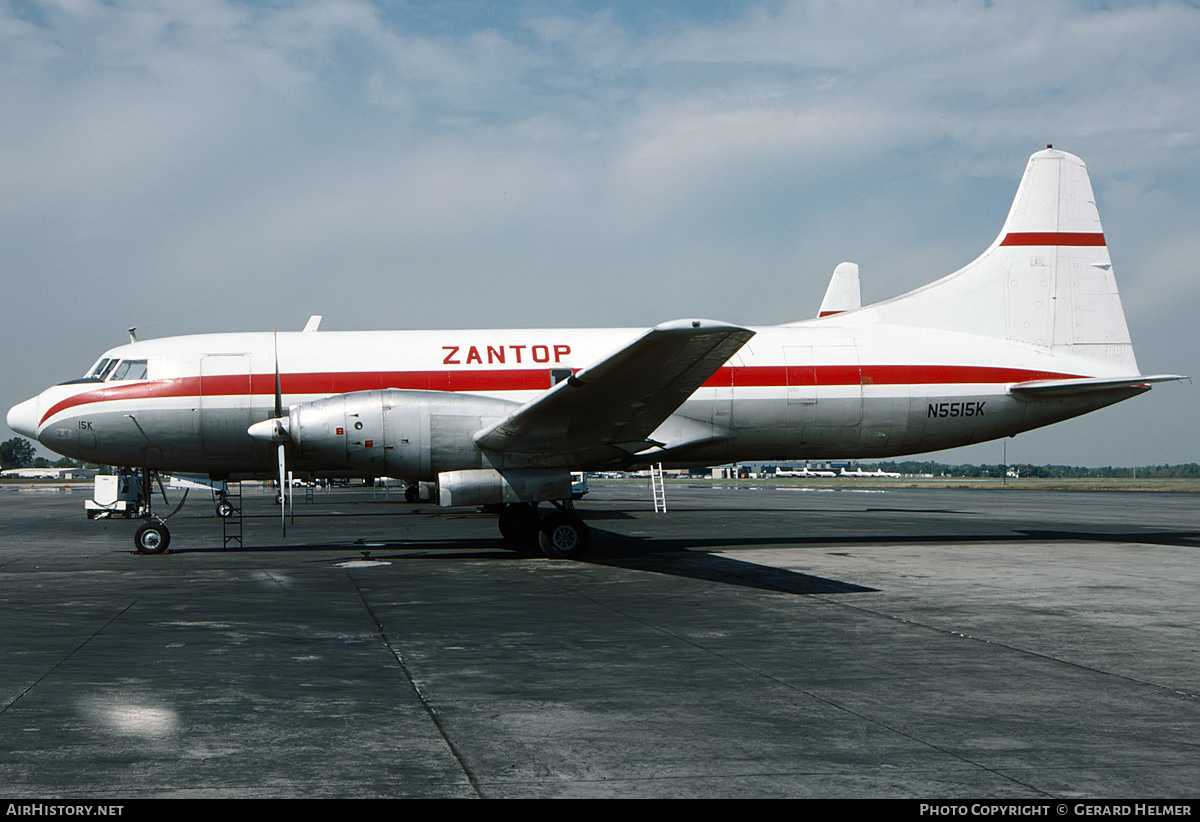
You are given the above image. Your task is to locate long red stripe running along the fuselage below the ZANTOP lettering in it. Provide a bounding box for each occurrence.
[38,365,1084,425]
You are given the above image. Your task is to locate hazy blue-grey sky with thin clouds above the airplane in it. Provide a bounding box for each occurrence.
[0,0,1200,464]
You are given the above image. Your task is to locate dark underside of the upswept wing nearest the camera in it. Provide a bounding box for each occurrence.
[475,319,754,466]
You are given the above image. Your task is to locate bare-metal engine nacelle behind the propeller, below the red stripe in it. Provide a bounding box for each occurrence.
[288,389,518,480]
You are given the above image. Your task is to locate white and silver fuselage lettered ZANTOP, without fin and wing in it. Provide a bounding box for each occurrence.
[8,317,1144,480]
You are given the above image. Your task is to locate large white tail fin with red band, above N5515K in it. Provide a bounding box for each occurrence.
[845,148,1139,374]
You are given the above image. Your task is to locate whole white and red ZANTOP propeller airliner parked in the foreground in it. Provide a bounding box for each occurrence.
[7,149,1178,556]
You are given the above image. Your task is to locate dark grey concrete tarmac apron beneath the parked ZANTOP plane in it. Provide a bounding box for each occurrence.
[0,482,1200,800]
